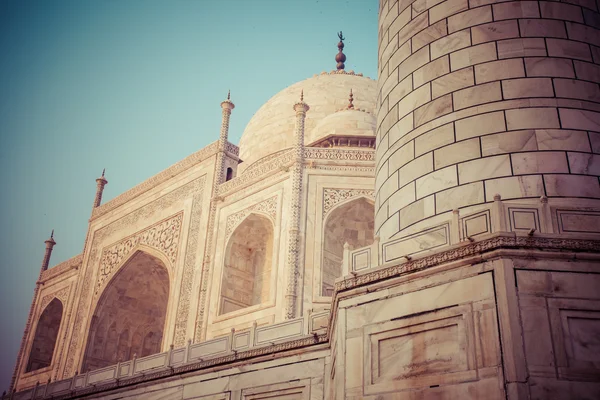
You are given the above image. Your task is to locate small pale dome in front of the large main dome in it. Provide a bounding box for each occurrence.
[305,109,377,145]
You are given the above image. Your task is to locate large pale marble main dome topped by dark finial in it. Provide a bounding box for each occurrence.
[238,71,377,173]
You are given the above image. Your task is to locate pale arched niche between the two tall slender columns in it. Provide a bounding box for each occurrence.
[219,214,273,314]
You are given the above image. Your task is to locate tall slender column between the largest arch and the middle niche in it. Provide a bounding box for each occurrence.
[195,92,235,345]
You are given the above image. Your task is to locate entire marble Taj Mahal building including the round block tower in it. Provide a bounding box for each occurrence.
[2,0,600,400]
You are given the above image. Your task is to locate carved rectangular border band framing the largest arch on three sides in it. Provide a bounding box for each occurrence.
[59,176,206,377]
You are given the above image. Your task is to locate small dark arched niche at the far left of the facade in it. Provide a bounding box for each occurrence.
[25,298,63,372]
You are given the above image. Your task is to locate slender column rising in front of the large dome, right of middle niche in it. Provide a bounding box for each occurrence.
[285,91,310,319]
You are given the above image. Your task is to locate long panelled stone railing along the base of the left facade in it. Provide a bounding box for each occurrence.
[1,310,330,400]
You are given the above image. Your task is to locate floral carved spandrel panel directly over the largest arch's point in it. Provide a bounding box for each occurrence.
[94,212,183,296]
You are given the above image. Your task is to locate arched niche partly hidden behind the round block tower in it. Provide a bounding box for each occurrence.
[321,197,375,296]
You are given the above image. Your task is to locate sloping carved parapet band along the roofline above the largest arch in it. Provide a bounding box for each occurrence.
[91,140,219,220]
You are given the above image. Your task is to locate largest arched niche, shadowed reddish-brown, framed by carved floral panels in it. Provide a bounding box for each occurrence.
[82,250,169,371]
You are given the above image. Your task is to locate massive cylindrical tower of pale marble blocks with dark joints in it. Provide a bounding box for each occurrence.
[375,0,600,240]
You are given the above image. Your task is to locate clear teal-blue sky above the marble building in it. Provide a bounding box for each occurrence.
[0,0,378,392]
